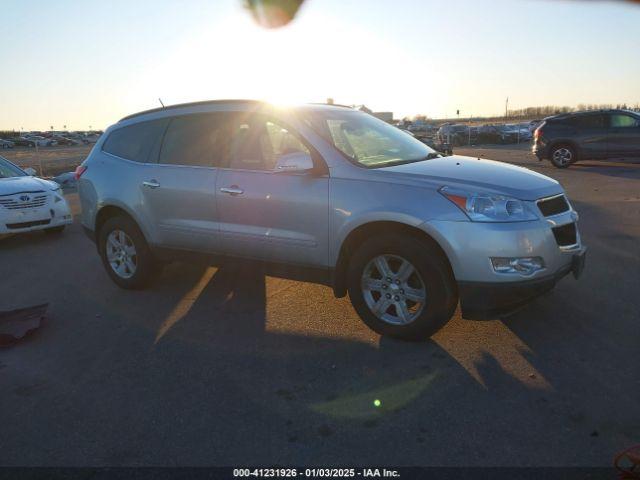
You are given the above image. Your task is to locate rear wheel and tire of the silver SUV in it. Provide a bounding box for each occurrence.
[98,216,162,290]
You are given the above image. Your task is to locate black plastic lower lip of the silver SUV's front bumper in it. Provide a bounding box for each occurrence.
[458,248,586,320]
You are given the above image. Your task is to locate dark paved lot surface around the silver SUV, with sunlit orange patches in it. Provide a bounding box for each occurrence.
[0,147,640,466]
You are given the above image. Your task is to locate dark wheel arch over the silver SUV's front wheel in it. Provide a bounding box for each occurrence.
[332,220,453,298]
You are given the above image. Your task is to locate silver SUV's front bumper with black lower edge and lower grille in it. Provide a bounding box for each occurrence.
[422,199,586,319]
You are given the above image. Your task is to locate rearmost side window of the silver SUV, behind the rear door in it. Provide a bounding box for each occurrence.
[102,119,167,163]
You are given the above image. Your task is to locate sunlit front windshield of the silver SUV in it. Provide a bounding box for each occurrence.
[303,109,439,168]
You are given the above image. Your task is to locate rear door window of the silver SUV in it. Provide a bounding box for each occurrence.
[160,113,230,167]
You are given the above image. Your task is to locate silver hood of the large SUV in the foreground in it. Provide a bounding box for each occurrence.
[379,155,563,200]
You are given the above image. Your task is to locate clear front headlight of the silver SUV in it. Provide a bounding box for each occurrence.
[439,187,538,222]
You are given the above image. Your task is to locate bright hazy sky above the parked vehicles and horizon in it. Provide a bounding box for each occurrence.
[0,0,640,131]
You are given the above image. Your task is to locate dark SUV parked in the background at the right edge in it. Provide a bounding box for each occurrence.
[533,110,640,168]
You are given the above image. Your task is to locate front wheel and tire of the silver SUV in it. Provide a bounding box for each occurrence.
[347,233,458,341]
